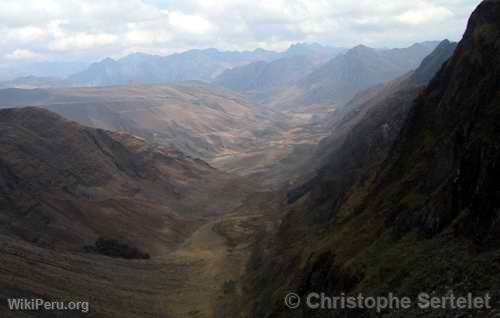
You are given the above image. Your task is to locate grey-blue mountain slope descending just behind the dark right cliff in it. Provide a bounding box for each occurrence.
[289,40,457,201]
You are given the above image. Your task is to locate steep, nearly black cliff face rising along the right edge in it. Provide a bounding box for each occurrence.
[373,1,500,240]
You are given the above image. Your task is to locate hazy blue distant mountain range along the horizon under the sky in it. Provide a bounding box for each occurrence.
[0,42,437,94]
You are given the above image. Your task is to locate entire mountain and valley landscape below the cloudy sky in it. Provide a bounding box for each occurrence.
[0,0,500,318]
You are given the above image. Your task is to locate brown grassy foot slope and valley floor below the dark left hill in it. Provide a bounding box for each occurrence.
[0,206,272,318]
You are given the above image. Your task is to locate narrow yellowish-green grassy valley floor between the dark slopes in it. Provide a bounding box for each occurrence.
[160,192,277,318]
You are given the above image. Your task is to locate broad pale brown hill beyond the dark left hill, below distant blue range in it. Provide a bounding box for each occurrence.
[0,82,277,159]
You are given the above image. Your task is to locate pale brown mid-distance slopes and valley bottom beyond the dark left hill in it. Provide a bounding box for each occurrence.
[0,82,331,187]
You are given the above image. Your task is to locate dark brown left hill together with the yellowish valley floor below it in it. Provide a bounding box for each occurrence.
[0,107,272,317]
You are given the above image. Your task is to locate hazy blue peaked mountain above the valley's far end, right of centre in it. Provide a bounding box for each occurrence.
[260,44,433,109]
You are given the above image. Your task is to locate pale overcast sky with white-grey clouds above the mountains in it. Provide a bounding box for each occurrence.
[0,0,480,64]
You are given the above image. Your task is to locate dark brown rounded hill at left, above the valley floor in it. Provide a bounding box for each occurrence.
[0,107,254,249]
